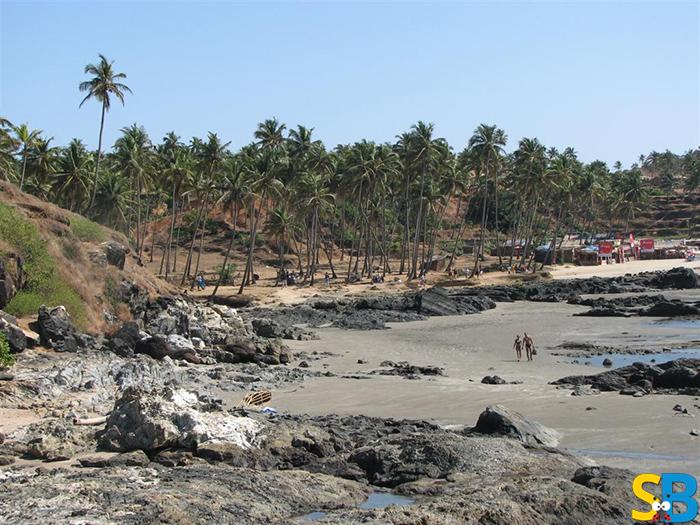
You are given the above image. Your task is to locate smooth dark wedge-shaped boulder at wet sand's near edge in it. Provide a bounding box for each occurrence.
[472,405,559,447]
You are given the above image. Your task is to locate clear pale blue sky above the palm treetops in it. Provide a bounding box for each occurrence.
[0,0,700,165]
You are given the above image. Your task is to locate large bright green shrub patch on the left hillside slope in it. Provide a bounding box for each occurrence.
[0,204,85,325]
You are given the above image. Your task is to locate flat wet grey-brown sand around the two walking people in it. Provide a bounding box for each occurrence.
[273,290,700,475]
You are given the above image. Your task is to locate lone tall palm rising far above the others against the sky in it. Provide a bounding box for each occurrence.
[78,54,132,212]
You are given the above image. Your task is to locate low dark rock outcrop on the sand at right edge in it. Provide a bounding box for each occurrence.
[552,359,700,395]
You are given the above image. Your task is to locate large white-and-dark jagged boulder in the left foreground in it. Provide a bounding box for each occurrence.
[99,388,262,452]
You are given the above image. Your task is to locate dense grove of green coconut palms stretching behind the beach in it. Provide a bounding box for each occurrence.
[0,56,700,291]
